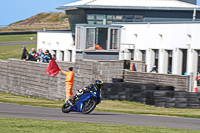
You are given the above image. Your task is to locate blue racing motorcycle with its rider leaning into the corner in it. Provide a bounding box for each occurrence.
[62,80,103,114]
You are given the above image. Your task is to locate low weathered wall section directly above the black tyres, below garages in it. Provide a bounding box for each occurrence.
[124,71,190,91]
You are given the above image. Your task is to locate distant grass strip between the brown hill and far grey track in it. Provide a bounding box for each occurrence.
[0,34,37,43]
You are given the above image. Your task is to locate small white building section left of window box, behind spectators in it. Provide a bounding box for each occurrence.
[37,31,76,62]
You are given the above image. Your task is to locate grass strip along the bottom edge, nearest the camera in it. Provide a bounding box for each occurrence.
[0,117,200,133]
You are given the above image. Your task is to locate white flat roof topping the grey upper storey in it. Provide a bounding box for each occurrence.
[57,0,200,10]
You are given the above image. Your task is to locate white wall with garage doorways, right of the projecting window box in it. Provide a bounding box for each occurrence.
[117,22,200,75]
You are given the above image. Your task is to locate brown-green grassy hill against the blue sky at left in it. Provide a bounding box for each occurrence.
[0,12,70,32]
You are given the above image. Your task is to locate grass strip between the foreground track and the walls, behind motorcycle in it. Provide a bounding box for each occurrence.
[0,92,200,118]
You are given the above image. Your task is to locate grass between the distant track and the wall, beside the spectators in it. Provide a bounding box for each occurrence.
[0,43,37,60]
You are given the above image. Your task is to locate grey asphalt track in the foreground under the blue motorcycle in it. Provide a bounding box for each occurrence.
[0,102,200,130]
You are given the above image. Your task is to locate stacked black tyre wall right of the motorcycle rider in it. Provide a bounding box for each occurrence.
[101,82,200,108]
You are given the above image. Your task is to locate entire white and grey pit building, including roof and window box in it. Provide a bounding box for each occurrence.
[38,0,200,75]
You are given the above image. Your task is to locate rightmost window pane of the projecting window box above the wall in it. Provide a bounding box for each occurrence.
[110,29,119,49]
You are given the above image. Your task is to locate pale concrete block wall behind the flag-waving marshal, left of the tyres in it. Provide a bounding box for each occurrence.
[0,59,123,100]
